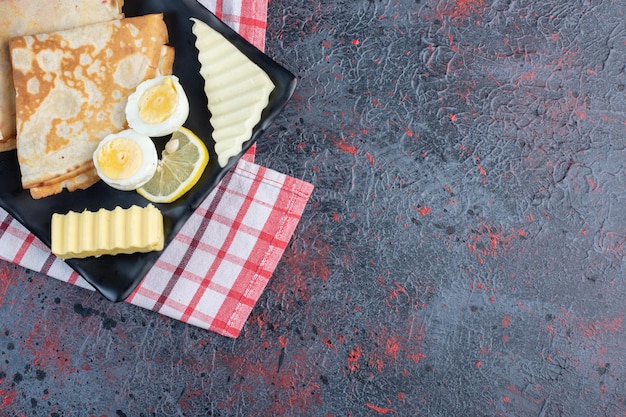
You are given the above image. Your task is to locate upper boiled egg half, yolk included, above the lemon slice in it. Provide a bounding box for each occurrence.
[125,75,189,137]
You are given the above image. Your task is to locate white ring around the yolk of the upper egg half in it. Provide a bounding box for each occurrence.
[125,75,189,137]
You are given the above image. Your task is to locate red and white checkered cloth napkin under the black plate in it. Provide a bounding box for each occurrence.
[0,0,313,337]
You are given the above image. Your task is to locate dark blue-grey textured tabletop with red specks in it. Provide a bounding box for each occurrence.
[0,0,626,417]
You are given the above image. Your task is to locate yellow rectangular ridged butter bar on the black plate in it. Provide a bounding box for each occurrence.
[51,204,164,259]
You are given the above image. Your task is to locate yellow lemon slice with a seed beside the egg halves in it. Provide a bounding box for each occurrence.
[137,127,209,203]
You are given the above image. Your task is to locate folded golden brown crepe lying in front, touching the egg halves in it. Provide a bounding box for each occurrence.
[10,14,173,198]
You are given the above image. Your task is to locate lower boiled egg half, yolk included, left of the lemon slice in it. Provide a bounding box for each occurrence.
[93,129,159,191]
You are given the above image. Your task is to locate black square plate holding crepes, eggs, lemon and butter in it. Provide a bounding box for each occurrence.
[0,0,296,301]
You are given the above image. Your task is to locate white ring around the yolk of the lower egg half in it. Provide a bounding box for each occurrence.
[93,129,159,191]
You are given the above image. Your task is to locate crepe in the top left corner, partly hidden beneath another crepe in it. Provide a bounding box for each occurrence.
[0,0,123,152]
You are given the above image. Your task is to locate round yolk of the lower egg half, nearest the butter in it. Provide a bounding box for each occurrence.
[97,138,143,180]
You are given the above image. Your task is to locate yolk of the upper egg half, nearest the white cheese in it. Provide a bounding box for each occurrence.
[138,78,178,124]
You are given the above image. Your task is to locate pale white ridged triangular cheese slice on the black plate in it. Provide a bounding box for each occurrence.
[191,18,275,167]
